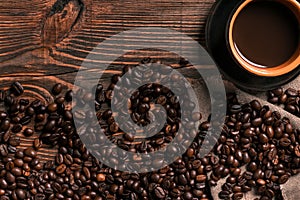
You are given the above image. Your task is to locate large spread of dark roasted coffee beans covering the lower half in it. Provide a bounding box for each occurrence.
[0,61,300,200]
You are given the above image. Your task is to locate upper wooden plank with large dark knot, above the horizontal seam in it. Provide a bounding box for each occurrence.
[0,0,213,74]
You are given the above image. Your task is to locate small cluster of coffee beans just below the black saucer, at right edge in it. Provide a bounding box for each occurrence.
[267,88,300,117]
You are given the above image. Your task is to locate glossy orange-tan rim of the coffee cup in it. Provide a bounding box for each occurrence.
[228,0,300,77]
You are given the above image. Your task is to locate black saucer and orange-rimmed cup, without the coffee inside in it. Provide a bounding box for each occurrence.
[206,0,300,91]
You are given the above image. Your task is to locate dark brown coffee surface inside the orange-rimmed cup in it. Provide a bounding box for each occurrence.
[232,1,299,68]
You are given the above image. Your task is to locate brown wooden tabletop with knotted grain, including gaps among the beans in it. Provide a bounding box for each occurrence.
[0,0,214,164]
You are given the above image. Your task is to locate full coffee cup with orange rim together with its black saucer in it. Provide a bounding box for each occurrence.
[206,0,300,91]
